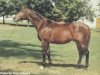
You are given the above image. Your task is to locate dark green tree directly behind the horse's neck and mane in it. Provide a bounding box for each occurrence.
[22,0,63,20]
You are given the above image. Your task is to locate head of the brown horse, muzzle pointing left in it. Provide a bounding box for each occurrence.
[13,9,28,22]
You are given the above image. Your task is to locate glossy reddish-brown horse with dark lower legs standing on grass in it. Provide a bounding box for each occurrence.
[13,8,90,68]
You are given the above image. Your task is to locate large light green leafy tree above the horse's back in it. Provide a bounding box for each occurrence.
[52,0,94,21]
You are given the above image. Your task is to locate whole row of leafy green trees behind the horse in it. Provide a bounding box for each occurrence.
[0,0,94,23]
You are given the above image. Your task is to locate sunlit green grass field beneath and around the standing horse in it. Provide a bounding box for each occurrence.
[0,24,100,75]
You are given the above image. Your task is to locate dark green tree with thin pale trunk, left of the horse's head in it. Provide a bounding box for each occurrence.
[0,0,23,23]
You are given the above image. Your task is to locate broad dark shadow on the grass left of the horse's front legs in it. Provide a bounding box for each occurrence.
[0,40,41,59]
